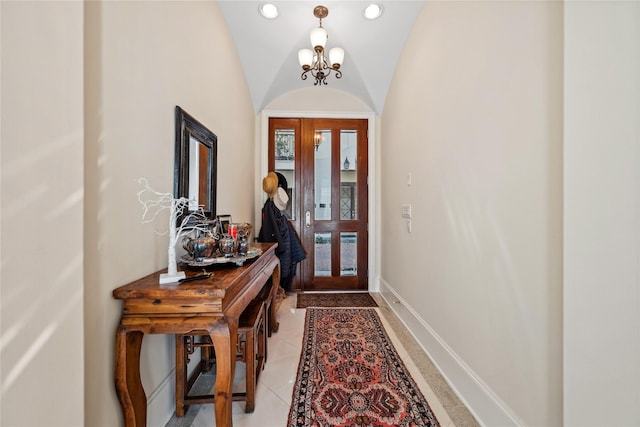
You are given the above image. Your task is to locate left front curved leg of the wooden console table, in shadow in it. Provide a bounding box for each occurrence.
[115,325,147,427]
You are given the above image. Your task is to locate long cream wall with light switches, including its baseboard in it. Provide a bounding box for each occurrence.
[380,1,562,426]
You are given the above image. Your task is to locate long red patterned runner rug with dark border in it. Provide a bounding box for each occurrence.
[288,308,439,427]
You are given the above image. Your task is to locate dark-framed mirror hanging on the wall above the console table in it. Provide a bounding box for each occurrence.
[173,106,218,219]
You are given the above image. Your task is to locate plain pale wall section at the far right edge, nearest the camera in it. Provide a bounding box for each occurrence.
[563,1,640,426]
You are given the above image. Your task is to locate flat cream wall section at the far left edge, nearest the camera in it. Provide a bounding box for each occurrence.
[0,1,85,427]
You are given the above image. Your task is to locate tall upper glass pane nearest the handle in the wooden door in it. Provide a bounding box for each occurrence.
[313,129,331,221]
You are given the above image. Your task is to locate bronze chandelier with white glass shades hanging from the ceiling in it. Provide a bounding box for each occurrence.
[298,6,344,86]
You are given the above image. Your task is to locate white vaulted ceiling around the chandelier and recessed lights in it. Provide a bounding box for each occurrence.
[218,0,424,114]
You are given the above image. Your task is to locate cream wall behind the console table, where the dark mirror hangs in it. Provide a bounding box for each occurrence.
[85,1,255,427]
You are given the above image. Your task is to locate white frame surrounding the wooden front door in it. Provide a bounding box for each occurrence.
[254,110,380,292]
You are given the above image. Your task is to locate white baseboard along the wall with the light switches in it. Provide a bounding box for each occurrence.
[379,278,524,426]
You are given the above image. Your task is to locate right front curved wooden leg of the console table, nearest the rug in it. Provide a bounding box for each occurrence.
[209,318,238,427]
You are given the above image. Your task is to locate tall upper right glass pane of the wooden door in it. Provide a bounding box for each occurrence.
[340,130,358,220]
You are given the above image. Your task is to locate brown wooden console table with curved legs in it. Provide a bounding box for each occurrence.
[113,243,280,427]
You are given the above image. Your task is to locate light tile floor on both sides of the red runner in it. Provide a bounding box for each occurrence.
[165,294,479,427]
